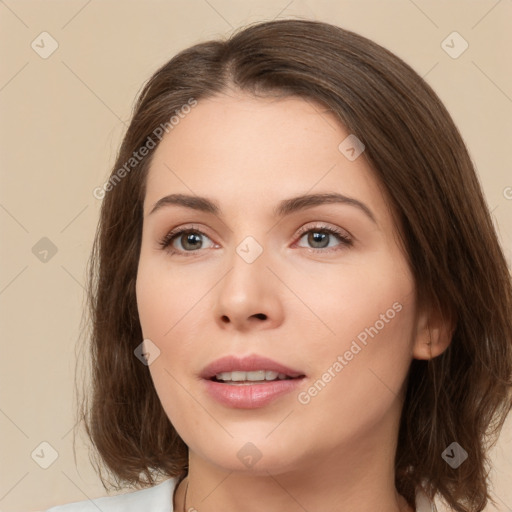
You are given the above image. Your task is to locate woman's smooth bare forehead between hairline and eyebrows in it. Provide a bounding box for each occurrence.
[144,93,390,224]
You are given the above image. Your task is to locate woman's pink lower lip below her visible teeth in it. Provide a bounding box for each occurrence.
[204,378,303,409]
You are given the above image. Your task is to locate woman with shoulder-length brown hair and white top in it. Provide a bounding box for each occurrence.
[46,20,512,512]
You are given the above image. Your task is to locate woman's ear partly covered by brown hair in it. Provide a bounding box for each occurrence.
[413,309,455,359]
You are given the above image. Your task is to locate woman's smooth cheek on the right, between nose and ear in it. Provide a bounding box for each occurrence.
[298,252,416,388]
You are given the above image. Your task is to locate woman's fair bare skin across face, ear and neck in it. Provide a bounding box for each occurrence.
[137,91,449,512]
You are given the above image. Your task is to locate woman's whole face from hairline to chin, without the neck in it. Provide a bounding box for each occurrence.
[137,93,419,474]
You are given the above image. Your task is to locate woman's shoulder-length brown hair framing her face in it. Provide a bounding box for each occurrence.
[79,20,512,512]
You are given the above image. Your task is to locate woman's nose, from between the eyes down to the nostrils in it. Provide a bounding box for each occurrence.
[213,243,284,331]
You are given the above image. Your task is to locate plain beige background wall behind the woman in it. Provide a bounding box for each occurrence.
[0,0,512,511]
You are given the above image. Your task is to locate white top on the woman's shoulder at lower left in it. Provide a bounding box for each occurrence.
[46,478,176,512]
